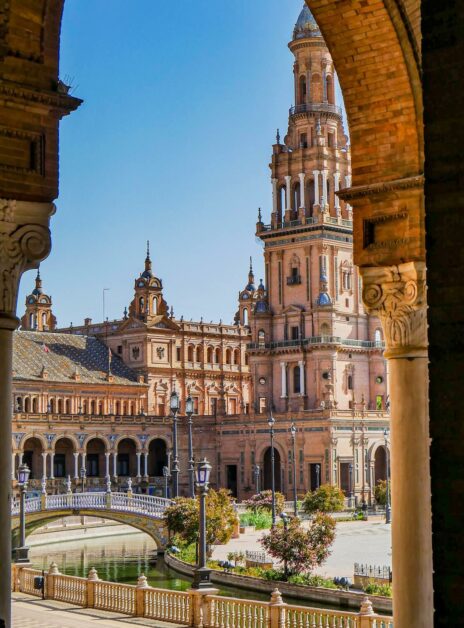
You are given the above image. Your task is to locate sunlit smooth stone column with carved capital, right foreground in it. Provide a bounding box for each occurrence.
[360,262,433,628]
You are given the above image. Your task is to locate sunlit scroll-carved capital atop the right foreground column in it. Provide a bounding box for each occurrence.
[360,262,428,358]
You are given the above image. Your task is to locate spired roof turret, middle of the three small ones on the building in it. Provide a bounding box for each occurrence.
[129,242,168,324]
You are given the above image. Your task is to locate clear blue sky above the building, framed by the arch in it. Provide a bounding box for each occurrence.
[18,0,342,326]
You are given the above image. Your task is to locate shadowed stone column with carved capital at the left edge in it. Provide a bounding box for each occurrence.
[0,199,54,628]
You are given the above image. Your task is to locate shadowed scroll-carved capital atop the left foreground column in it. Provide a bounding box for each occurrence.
[0,199,55,328]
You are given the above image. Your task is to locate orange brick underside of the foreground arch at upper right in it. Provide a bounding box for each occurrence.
[306,0,423,186]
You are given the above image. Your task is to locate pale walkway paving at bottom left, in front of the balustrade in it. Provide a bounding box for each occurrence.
[12,593,180,628]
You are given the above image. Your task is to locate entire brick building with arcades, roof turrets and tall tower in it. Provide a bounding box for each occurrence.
[13,7,389,503]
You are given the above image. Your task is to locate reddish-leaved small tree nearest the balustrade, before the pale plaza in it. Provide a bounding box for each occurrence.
[260,512,335,575]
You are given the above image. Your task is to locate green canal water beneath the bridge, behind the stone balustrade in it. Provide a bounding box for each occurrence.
[29,533,342,608]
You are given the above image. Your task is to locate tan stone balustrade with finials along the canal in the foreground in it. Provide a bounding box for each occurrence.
[12,563,393,628]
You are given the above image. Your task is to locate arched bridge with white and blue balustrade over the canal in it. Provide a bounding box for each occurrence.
[11,492,171,552]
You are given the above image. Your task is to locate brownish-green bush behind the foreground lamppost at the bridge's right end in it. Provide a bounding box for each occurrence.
[165,489,238,546]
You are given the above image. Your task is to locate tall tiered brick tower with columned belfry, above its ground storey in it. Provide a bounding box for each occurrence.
[246,6,387,413]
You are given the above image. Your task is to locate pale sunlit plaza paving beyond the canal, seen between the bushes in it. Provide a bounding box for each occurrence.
[213,516,391,578]
